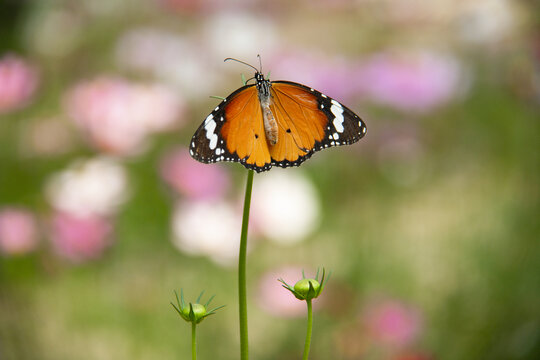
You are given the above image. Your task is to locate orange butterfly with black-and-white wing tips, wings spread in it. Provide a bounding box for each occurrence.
[189,57,366,172]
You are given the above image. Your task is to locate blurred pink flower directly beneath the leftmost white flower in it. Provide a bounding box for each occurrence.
[51,213,112,263]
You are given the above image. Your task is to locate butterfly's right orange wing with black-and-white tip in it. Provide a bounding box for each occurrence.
[269,81,366,167]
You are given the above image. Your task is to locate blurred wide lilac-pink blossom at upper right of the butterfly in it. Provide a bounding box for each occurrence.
[352,52,467,112]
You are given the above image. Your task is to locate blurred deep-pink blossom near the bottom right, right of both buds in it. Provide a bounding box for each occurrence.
[364,300,422,347]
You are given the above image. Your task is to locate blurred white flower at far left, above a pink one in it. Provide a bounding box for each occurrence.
[46,157,128,216]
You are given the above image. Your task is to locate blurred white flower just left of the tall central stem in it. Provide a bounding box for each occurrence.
[172,201,242,265]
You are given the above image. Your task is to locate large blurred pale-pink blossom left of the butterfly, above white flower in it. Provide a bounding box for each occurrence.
[66,77,185,155]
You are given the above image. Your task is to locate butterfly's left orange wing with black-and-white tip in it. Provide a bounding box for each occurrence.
[190,85,271,172]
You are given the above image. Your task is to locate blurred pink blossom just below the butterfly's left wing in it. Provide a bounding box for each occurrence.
[160,148,230,200]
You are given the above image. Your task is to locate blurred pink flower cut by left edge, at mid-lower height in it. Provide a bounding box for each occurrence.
[0,208,38,255]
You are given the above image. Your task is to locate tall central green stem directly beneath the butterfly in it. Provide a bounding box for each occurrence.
[238,170,253,360]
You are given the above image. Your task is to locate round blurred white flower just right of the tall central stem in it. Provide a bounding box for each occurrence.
[251,169,320,244]
